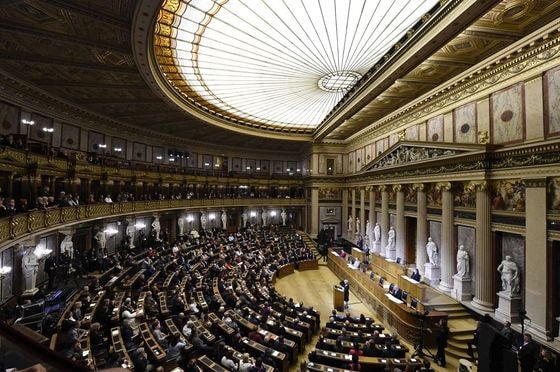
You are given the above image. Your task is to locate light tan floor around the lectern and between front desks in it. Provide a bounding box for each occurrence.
[275,264,458,371]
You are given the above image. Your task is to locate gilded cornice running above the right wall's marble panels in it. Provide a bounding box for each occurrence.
[345,25,560,151]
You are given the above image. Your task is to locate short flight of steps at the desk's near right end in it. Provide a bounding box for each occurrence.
[433,302,476,361]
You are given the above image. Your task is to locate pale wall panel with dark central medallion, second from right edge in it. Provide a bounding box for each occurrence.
[490,84,525,144]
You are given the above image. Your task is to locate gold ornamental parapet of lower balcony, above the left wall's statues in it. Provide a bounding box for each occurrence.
[0,198,305,250]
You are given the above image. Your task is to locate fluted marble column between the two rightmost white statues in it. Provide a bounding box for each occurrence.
[468,181,496,313]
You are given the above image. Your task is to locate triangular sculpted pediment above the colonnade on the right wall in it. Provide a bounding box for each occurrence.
[361,141,488,172]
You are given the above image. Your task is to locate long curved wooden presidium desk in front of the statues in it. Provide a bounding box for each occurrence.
[328,249,447,345]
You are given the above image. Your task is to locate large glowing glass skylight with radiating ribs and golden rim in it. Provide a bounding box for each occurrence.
[154,0,439,133]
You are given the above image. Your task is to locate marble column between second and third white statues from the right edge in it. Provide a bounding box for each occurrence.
[436,182,455,293]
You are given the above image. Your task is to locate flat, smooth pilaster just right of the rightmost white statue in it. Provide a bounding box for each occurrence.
[521,178,556,339]
